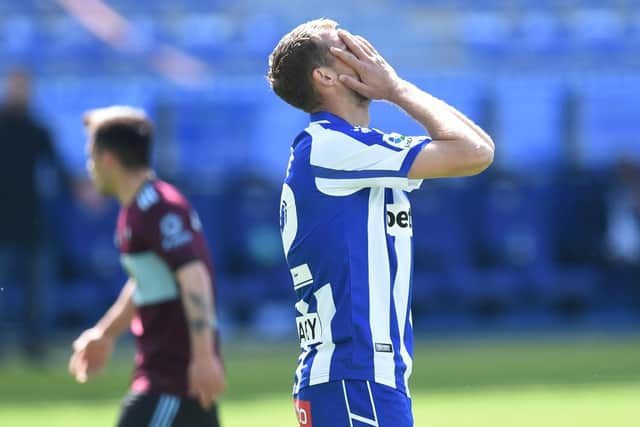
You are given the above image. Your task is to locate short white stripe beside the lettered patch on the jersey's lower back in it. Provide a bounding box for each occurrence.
[309,283,336,385]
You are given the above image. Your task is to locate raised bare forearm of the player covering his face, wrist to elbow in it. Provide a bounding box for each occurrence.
[390,81,492,147]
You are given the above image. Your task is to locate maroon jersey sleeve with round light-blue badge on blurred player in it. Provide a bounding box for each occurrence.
[144,204,201,271]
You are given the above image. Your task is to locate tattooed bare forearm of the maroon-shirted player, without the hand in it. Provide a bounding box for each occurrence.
[177,261,215,357]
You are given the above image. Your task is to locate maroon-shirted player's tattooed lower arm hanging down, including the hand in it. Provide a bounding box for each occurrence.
[176,260,225,408]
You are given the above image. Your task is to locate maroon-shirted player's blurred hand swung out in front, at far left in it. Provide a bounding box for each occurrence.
[69,328,113,383]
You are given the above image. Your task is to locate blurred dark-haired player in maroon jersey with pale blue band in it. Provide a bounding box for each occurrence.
[69,106,224,427]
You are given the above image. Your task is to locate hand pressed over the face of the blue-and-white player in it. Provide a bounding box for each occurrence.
[330,30,401,100]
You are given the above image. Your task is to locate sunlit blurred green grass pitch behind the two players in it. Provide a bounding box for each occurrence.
[0,335,640,427]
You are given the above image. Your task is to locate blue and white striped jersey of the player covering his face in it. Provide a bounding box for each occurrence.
[280,112,430,394]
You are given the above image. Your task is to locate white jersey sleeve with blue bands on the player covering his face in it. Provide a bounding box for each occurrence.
[310,127,431,195]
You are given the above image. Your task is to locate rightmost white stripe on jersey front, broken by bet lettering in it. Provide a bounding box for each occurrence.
[393,190,413,397]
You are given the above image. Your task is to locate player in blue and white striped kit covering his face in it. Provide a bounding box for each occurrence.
[267,19,494,427]
